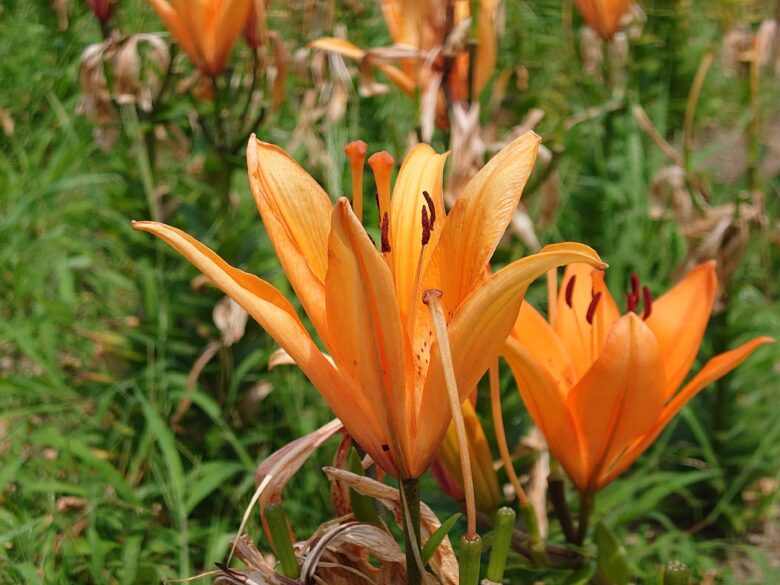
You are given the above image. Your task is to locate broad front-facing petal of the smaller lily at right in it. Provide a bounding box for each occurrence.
[566,313,664,489]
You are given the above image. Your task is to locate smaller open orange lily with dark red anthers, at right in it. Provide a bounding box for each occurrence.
[504,262,772,492]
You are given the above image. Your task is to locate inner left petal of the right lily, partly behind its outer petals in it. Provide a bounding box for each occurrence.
[509,302,576,396]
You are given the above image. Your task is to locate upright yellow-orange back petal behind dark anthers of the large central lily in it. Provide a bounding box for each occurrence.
[390,144,447,326]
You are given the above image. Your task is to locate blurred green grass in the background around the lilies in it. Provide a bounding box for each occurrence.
[0,0,780,584]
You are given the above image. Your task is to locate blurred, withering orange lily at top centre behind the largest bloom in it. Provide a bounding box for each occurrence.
[311,0,497,103]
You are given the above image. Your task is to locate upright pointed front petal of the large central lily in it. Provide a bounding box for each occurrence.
[325,199,412,477]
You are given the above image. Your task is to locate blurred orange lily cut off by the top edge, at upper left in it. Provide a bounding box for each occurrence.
[149,0,250,77]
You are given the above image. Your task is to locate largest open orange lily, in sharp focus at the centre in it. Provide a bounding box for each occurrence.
[134,133,604,479]
